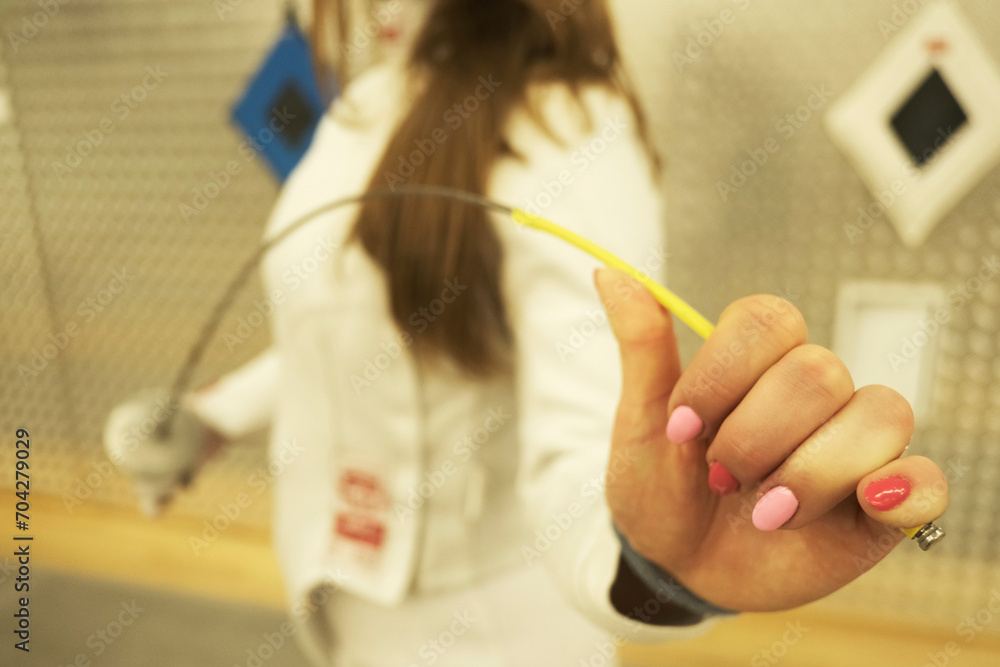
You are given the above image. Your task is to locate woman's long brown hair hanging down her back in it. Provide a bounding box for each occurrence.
[313,0,659,377]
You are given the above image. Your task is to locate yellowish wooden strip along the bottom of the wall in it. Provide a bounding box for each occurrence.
[25,488,1000,667]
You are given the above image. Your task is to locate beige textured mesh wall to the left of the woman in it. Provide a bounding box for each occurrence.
[0,0,304,522]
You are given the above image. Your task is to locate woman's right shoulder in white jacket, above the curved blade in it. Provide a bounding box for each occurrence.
[490,76,662,266]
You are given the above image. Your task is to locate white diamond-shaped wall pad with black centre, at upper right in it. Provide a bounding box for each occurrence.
[825,0,1000,247]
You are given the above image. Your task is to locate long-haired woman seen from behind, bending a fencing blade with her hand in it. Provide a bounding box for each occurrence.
[184,0,943,666]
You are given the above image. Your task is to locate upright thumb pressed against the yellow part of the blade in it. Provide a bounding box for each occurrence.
[594,268,681,416]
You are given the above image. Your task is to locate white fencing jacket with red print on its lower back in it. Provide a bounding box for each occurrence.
[196,66,707,641]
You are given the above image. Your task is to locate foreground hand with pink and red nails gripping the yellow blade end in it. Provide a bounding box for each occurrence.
[595,269,948,611]
